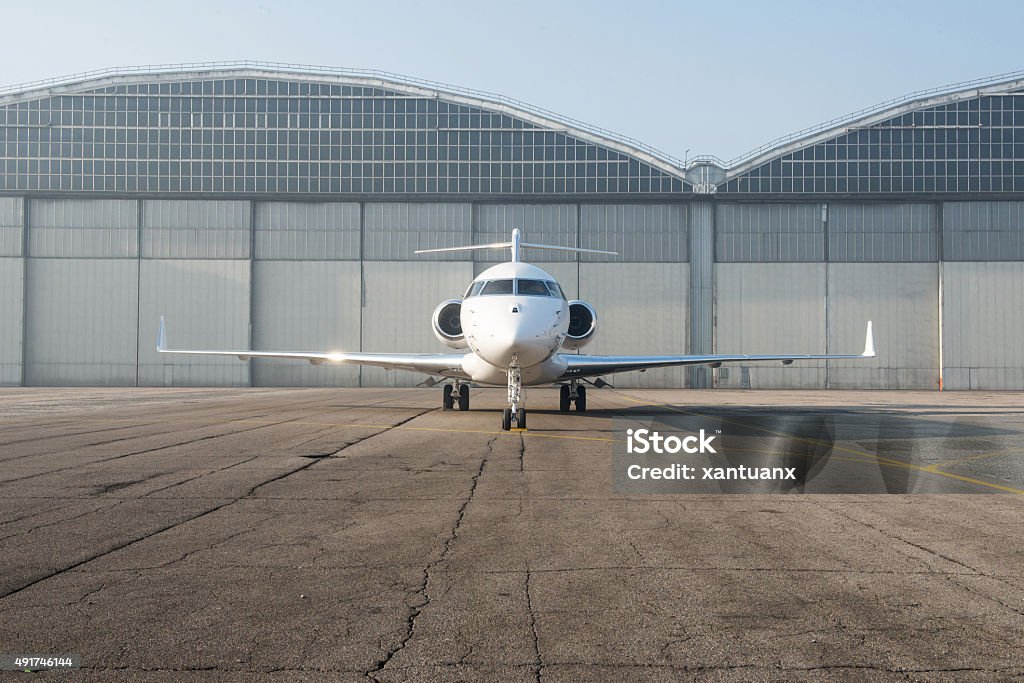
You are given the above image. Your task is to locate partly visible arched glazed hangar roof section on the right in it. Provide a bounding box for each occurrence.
[712,73,1024,195]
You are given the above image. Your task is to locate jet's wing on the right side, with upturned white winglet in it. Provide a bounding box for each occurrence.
[559,321,874,379]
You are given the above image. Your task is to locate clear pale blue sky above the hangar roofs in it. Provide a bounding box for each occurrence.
[0,0,1024,160]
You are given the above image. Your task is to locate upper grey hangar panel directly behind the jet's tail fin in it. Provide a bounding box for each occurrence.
[473,204,579,263]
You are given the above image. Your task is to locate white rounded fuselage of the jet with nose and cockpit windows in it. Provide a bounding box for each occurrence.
[462,261,569,384]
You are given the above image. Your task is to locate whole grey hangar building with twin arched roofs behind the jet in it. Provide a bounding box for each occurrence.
[0,61,1024,389]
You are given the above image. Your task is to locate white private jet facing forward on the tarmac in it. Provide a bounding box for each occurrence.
[157,228,874,431]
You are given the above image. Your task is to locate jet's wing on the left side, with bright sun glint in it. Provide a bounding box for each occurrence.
[157,316,469,379]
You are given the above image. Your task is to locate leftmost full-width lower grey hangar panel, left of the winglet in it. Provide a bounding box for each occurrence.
[25,258,138,386]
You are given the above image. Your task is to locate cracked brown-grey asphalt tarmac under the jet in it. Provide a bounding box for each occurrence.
[0,387,1024,681]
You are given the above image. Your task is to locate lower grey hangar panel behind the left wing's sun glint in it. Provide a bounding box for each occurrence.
[252,261,360,386]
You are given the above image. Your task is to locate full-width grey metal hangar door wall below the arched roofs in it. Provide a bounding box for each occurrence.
[0,198,1024,389]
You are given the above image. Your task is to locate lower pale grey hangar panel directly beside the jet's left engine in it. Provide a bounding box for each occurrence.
[362,261,473,393]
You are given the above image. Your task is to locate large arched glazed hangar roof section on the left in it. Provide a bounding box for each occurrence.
[0,61,691,195]
